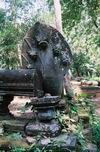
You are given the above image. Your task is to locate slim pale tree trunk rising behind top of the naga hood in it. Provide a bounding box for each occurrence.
[54,0,62,33]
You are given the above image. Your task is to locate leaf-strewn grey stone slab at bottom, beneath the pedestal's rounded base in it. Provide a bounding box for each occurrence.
[26,133,77,152]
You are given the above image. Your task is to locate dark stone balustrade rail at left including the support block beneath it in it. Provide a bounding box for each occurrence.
[0,69,37,114]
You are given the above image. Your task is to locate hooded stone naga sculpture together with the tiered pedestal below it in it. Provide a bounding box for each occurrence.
[22,22,72,140]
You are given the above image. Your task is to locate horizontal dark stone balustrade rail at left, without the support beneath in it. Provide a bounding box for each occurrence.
[0,69,43,96]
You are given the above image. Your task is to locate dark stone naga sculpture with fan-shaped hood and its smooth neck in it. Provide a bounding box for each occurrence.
[22,22,72,95]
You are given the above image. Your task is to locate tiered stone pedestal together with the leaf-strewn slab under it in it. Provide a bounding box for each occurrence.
[25,95,77,151]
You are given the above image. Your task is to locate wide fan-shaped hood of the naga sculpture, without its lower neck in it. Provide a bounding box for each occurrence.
[22,22,72,68]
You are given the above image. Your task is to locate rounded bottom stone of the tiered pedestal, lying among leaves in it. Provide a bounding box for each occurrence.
[25,120,61,137]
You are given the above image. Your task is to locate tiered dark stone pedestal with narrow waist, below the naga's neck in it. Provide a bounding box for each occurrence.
[25,95,61,137]
